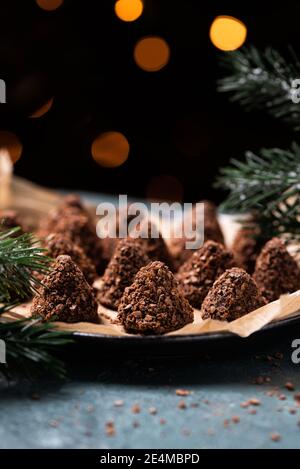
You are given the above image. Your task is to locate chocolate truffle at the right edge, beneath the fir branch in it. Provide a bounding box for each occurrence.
[253,238,300,301]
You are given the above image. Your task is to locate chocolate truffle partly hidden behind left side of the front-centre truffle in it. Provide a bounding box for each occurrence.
[98,238,149,309]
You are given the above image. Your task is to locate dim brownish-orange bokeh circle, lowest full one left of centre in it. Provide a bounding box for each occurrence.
[91,132,130,168]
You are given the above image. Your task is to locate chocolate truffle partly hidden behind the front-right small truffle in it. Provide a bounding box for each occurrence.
[177,241,234,309]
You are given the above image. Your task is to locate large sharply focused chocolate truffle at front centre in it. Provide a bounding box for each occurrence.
[118,261,194,334]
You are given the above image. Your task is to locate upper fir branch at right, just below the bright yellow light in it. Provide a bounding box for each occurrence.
[218,46,300,131]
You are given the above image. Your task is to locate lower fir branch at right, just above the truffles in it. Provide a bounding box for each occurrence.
[216,143,300,240]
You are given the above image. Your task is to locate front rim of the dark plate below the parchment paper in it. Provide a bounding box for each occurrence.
[74,312,300,356]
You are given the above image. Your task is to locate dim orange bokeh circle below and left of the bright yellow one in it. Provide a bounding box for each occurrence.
[134,36,170,72]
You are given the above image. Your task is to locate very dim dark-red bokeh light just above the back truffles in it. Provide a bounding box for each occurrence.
[146,174,183,202]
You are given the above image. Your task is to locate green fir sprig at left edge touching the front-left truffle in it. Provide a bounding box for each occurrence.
[0,228,51,312]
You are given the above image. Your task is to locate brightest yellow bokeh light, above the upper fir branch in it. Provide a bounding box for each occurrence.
[209,16,247,51]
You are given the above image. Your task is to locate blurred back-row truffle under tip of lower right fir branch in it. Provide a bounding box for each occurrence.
[232,225,262,274]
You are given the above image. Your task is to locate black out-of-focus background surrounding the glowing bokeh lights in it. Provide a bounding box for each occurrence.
[0,0,300,201]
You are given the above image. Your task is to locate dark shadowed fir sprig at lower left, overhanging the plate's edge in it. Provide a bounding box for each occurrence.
[0,319,73,378]
